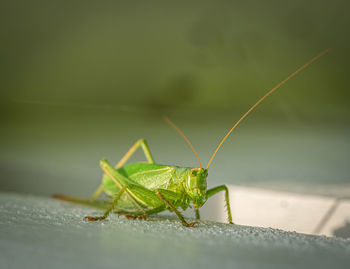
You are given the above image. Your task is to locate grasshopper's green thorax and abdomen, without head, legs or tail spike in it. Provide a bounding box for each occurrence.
[102,163,191,215]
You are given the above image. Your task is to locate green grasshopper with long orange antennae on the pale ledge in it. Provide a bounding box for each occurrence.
[54,50,328,227]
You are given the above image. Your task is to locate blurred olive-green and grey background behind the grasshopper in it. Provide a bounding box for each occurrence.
[0,0,350,197]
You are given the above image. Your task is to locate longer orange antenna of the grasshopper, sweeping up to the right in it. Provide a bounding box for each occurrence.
[206,49,330,169]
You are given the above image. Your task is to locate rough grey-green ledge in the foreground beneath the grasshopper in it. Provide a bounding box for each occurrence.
[0,193,350,268]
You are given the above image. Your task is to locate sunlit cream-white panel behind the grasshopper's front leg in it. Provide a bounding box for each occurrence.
[213,185,350,238]
